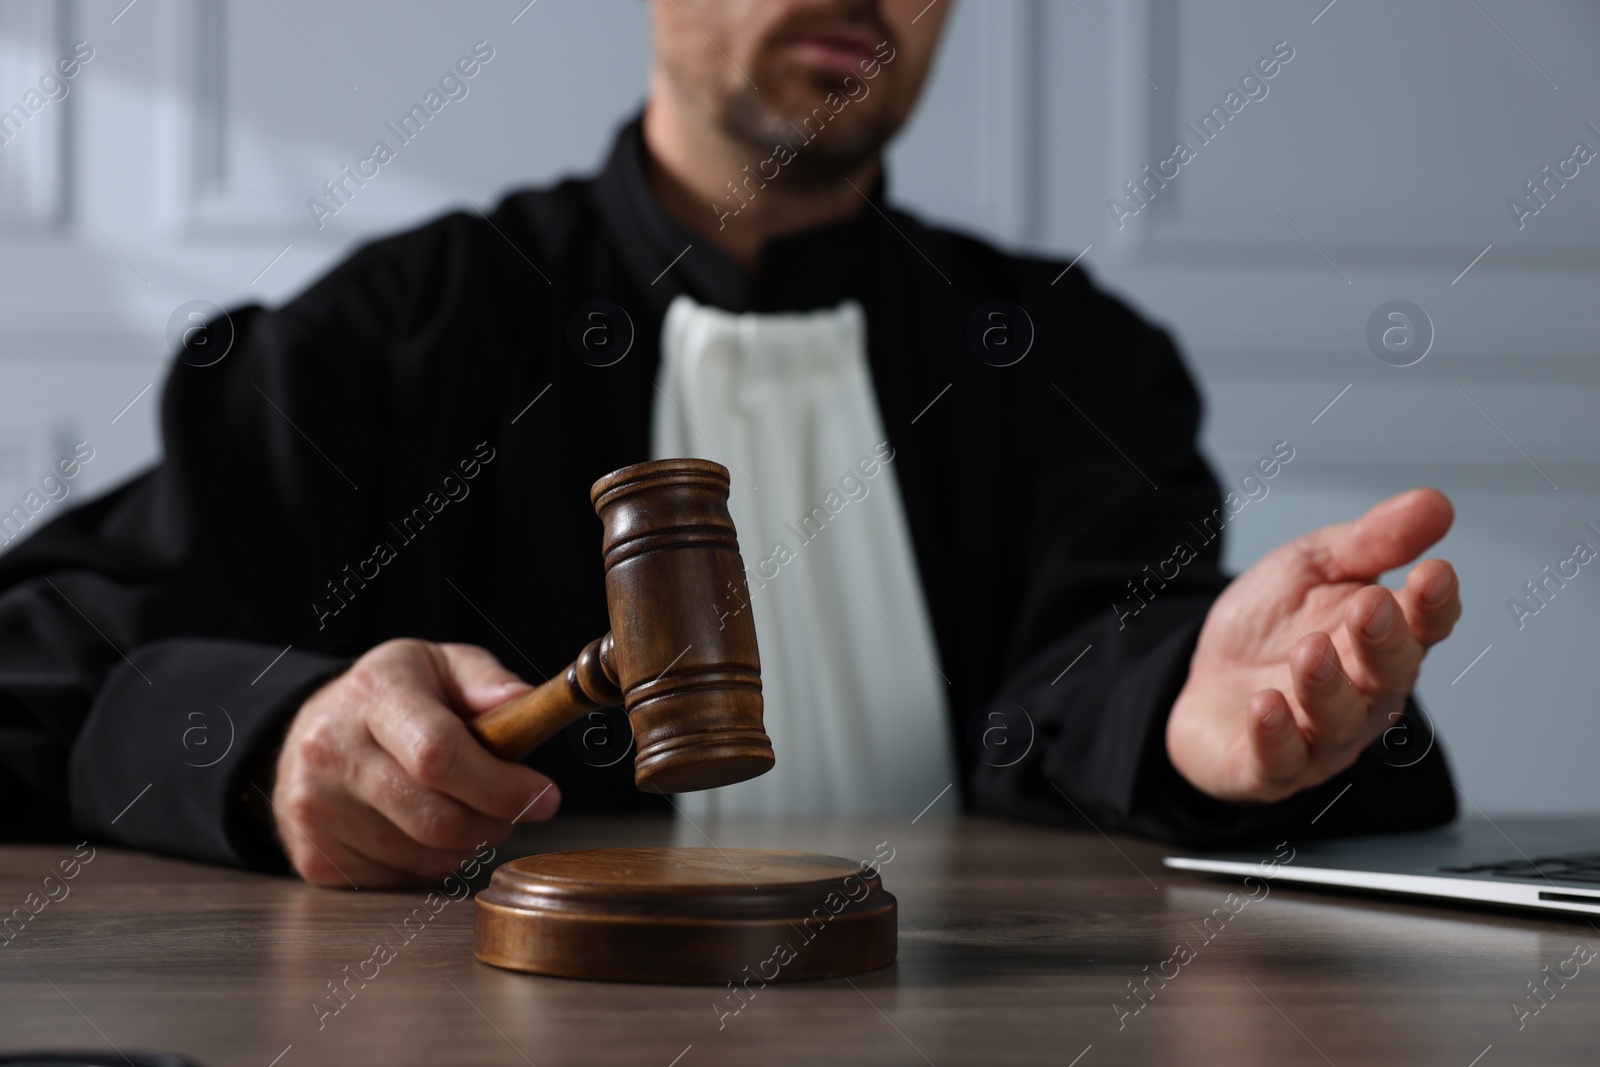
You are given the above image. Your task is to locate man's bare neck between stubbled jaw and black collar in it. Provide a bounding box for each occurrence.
[643,85,882,270]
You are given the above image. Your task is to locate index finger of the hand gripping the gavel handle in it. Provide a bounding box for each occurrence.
[366,688,562,822]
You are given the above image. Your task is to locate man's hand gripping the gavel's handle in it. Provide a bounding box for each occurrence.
[272,640,562,889]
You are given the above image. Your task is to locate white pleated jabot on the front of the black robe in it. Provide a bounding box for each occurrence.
[651,296,955,817]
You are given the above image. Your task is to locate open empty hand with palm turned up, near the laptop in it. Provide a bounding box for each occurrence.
[1166,490,1461,803]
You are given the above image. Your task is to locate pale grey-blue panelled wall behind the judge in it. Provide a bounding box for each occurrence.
[0,0,1600,811]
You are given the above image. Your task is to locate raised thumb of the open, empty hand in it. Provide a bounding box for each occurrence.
[1293,490,1456,582]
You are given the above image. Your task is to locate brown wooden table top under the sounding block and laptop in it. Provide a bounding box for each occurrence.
[0,814,1600,1067]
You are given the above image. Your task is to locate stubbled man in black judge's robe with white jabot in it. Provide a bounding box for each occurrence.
[0,0,1459,886]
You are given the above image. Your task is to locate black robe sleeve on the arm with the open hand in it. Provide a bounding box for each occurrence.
[968,281,1454,846]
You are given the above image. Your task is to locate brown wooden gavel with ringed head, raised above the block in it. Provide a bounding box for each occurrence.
[469,459,773,793]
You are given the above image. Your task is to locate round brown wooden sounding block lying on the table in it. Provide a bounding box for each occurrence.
[474,848,896,985]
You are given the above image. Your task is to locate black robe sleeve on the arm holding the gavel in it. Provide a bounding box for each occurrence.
[0,233,418,867]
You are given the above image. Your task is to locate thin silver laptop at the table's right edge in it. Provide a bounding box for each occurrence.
[1163,816,1600,915]
